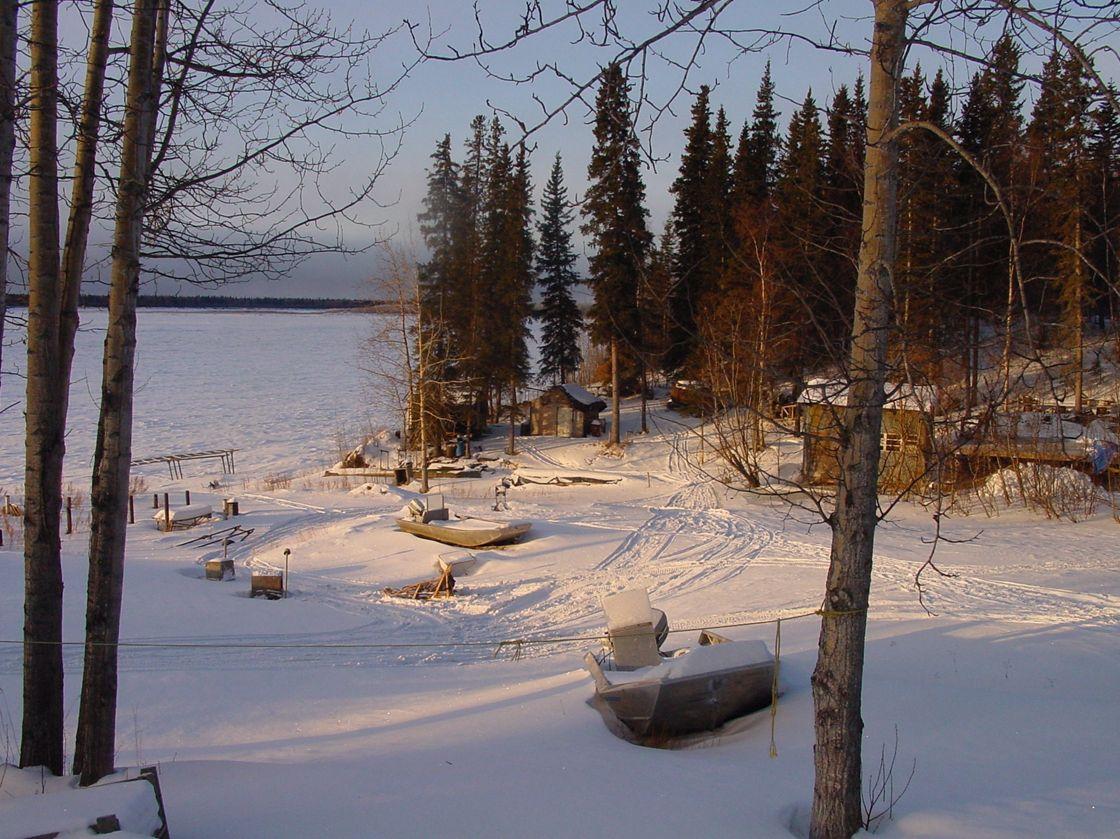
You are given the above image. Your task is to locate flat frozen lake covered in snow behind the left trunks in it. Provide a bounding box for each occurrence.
[0,309,392,495]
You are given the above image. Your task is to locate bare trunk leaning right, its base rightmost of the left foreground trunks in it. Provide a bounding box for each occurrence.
[74,0,168,784]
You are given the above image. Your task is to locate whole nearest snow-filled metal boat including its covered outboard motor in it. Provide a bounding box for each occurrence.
[584,590,774,739]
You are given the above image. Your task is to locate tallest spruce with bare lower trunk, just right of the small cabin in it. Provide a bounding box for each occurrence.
[582,64,652,445]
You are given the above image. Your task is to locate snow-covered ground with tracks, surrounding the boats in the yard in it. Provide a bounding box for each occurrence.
[0,315,1120,839]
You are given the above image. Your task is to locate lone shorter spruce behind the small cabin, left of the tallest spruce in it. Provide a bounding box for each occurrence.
[536,152,584,384]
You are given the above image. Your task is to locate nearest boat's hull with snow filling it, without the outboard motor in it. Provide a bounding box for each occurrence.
[584,632,774,737]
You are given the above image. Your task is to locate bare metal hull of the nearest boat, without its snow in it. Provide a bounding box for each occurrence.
[585,642,774,737]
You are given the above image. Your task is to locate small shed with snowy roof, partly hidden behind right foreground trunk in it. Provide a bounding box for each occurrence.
[797,379,934,490]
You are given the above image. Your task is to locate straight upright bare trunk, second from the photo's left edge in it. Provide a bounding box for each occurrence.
[19,0,66,775]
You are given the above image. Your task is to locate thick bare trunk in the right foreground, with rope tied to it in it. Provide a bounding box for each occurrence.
[810,0,907,839]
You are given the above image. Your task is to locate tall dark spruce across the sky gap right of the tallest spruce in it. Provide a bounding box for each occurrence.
[664,85,716,370]
